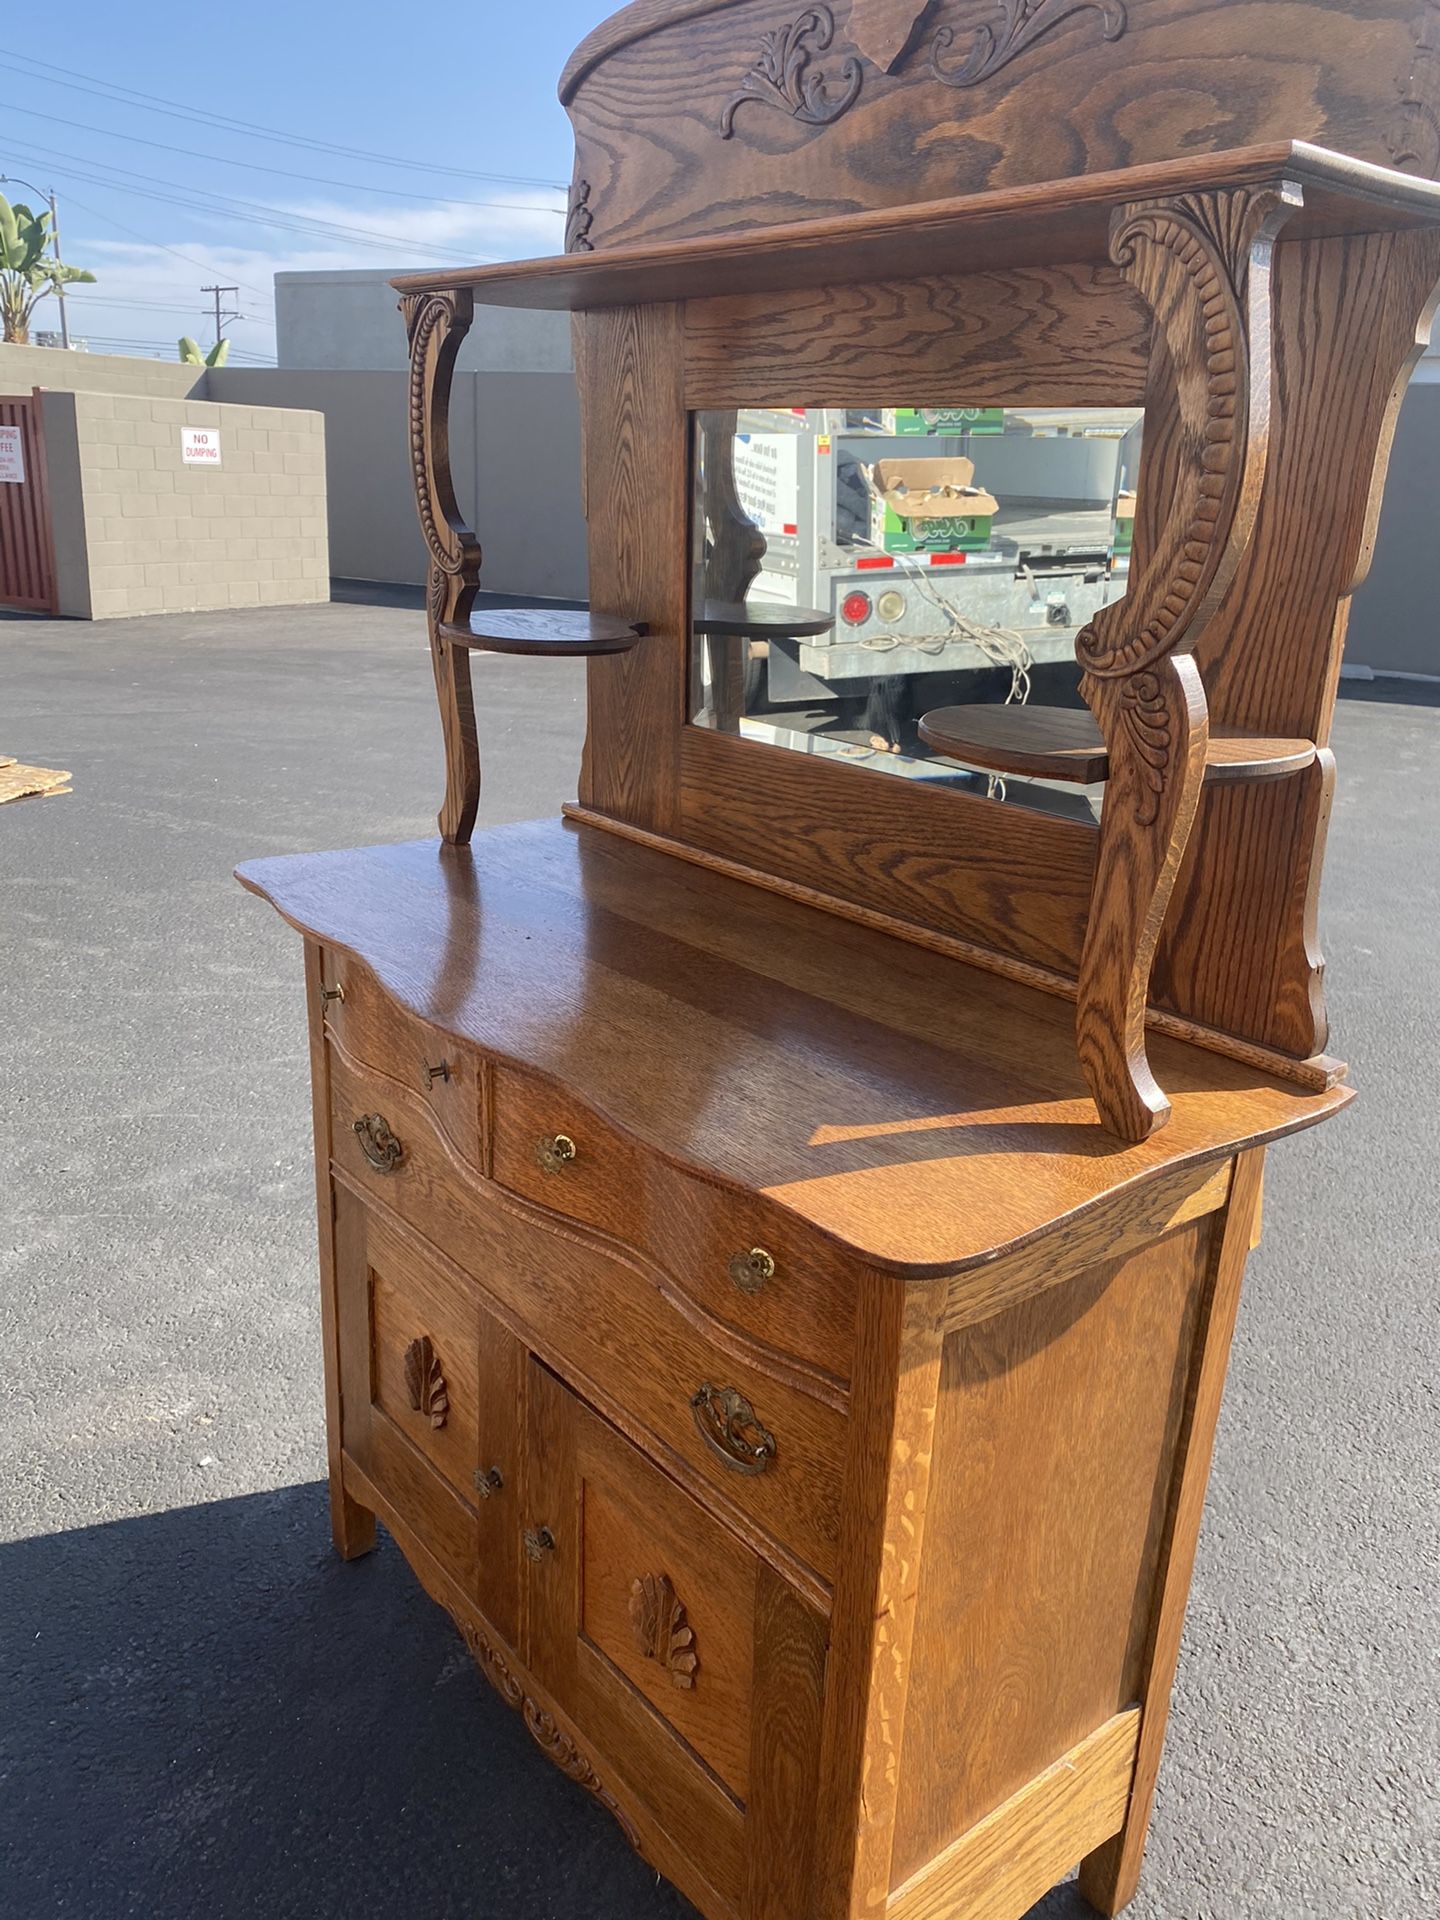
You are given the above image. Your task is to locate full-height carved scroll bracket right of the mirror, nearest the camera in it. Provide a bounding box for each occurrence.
[1075,182,1302,1140]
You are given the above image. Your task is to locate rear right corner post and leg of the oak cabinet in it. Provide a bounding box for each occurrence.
[1079,1146,1265,1914]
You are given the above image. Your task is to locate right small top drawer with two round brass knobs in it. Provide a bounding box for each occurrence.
[493,1068,856,1382]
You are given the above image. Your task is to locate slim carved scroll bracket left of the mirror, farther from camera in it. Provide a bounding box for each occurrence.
[399,288,482,843]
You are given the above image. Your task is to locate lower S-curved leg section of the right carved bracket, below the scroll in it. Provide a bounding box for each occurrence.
[1075,655,1210,1140]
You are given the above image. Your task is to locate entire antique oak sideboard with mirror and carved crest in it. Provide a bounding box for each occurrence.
[240,0,1440,1920]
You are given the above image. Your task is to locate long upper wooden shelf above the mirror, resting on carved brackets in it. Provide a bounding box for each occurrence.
[390,140,1440,311]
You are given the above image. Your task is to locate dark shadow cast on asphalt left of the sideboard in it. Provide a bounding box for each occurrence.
[0,1484,1089,1920]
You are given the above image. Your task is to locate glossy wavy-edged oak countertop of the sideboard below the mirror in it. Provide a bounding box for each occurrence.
[238,820,1350,1275]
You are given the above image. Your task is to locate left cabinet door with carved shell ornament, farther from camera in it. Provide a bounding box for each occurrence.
[336,1190,524,1645]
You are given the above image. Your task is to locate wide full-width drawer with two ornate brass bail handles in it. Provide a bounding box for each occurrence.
[330,1052,845,1582]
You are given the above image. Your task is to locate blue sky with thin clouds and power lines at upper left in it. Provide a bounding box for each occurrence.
[0,0,618,359]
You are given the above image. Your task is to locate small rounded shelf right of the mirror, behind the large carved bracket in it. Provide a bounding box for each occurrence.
[920,707,1315,787]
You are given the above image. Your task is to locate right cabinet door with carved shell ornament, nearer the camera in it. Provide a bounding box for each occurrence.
[524,1361,826,1920]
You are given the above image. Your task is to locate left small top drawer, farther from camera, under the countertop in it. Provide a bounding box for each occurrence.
[321,950,482,1167]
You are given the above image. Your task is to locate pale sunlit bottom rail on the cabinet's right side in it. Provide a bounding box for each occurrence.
[885,1707,1140,1920]
